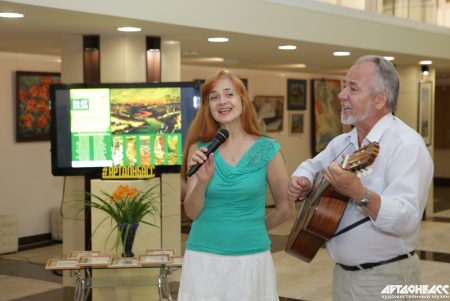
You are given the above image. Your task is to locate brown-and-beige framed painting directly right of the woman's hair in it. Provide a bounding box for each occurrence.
[253,96,284,132]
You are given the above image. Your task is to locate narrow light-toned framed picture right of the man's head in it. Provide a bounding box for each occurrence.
[418,81,433,145]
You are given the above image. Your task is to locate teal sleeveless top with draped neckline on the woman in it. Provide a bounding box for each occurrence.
[186,137,280,255]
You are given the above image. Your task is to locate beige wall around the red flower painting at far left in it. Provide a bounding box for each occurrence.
[0,53,64,237]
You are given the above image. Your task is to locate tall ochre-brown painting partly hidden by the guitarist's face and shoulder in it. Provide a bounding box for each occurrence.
[311,79,343,156]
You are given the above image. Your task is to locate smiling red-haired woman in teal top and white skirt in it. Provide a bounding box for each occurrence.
[178,71,294,301]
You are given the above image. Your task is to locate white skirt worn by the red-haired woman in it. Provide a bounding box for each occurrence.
[177,250,279,301]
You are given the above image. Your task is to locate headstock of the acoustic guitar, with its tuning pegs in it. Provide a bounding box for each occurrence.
[342,142,380,175]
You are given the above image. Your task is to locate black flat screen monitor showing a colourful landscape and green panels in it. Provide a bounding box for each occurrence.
[50,82,200,176]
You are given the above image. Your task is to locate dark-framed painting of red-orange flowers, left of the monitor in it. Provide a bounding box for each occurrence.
[16,71,61,142]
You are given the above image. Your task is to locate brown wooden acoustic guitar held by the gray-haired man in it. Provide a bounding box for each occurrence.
[285,142,380,262]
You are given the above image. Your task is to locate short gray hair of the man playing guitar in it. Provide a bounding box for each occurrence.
[355,55,400,113]
